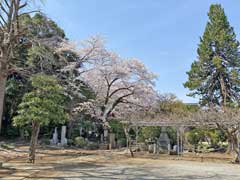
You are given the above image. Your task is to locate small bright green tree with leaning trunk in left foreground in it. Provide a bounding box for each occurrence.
[13,74,68,163]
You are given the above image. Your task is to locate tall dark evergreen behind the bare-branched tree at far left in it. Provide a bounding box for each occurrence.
[1,13,66,136]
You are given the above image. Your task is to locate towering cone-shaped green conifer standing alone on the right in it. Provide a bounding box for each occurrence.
[184,4,240,106]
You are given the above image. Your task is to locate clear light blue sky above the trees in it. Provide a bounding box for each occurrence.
[41,0,240,102]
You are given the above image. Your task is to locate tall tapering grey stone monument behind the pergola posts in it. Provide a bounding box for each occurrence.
[158,127,170,153]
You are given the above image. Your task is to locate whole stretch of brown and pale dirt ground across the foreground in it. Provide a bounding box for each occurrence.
[0,146,240,180]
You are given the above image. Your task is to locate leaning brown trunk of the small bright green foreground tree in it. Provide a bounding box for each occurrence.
[28,122,40,163]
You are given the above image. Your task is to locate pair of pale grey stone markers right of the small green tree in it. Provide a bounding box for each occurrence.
[50,126,67,146]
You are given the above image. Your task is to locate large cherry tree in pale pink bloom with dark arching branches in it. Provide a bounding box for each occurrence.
[75,39,157,127]
